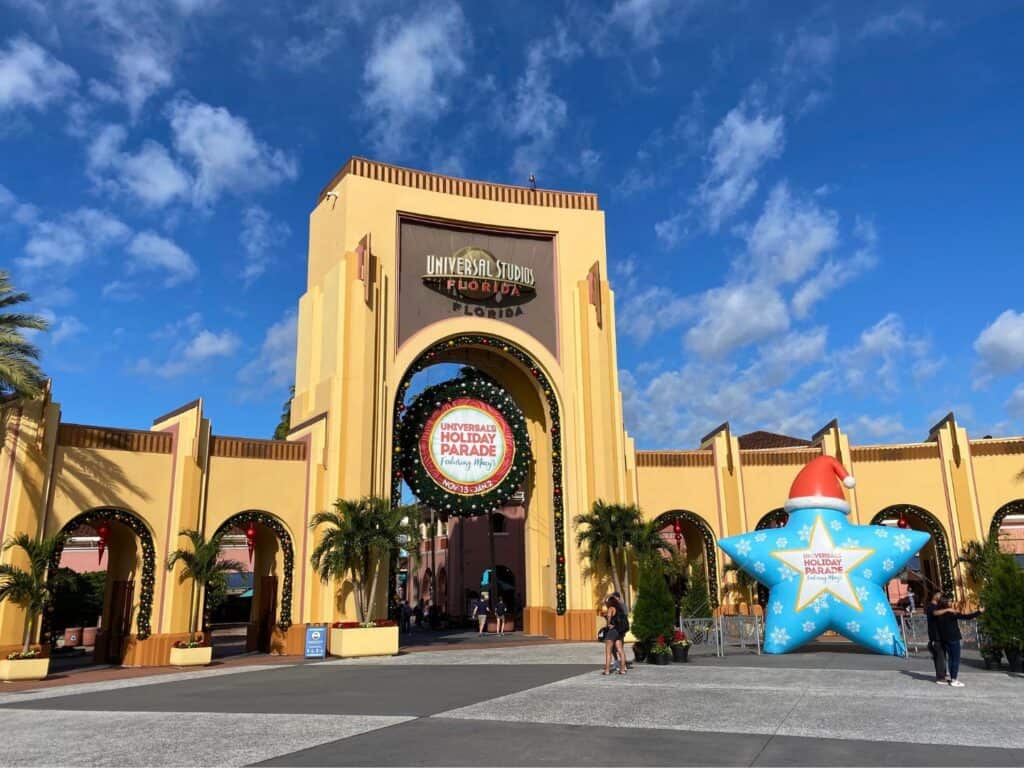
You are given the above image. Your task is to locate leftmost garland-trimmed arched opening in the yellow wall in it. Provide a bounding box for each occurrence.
[44,508,156,665]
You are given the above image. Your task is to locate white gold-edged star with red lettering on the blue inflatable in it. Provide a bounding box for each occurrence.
[771,516,874,612]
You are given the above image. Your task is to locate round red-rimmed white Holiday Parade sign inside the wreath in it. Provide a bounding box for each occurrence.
[420,397,515,496]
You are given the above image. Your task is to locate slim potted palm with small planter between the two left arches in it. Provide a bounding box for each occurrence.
[167,528,245,667]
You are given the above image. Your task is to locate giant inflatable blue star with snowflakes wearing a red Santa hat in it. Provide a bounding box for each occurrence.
[718,457,930,655]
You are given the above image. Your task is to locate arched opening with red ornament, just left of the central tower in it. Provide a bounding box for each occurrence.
[204,510,295,656]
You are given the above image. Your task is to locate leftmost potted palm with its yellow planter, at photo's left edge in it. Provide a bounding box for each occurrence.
[0,534,63,681]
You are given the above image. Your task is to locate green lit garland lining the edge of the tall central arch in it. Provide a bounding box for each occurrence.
[390,334,565,615]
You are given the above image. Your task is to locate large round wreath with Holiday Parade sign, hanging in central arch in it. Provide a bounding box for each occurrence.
[395,369,534,516]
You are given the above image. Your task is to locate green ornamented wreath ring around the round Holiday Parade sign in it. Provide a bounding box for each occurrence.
[395,370,534,517]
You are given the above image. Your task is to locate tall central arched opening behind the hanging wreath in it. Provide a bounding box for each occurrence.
[391,335,565,634]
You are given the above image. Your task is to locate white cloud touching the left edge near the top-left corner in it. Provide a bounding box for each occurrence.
[0,37,78,112]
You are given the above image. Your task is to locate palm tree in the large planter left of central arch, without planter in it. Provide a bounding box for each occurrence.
[309,496,422,624]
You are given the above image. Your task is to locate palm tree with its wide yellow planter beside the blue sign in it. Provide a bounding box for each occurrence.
[310,497,421,657]
